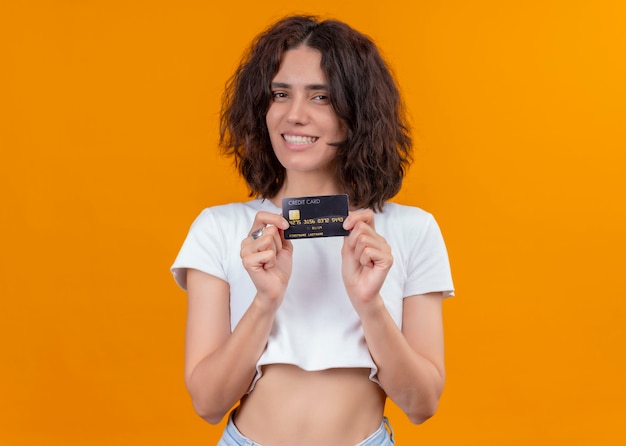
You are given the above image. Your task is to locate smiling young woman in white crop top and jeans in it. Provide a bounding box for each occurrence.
[172,16,453,446]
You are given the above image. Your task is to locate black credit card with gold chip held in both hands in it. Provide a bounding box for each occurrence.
[283,194,350,239]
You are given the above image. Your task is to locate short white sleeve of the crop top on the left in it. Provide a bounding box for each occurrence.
[171,209,226,290]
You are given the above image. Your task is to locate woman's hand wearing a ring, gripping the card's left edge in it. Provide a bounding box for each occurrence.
[241,212,293,307]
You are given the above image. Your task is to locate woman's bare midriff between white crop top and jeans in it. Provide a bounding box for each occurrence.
[235,364,386,446]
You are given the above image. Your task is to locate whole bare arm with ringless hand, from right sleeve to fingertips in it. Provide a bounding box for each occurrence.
[342,211,445,423]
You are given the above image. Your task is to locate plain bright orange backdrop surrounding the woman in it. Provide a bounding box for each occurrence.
[0,0,626,445]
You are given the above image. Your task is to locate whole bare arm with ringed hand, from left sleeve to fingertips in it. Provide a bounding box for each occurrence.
[185,212,292,423]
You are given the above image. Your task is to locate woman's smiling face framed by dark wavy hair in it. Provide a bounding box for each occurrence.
[265,46,346,183]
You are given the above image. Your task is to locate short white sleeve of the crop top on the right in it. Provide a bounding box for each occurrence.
[404,213,454,297]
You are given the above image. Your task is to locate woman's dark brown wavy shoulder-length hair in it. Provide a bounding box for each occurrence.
[220,16,412,211]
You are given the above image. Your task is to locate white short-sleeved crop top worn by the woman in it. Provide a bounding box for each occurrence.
[172,199,453,391]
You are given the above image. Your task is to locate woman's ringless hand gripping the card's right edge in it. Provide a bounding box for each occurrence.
[341,209,393,312]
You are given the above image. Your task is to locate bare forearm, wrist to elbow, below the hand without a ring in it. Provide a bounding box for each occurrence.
[358,296,445,423]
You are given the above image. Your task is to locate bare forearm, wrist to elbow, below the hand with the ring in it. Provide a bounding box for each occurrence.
[187,298,276,423]
